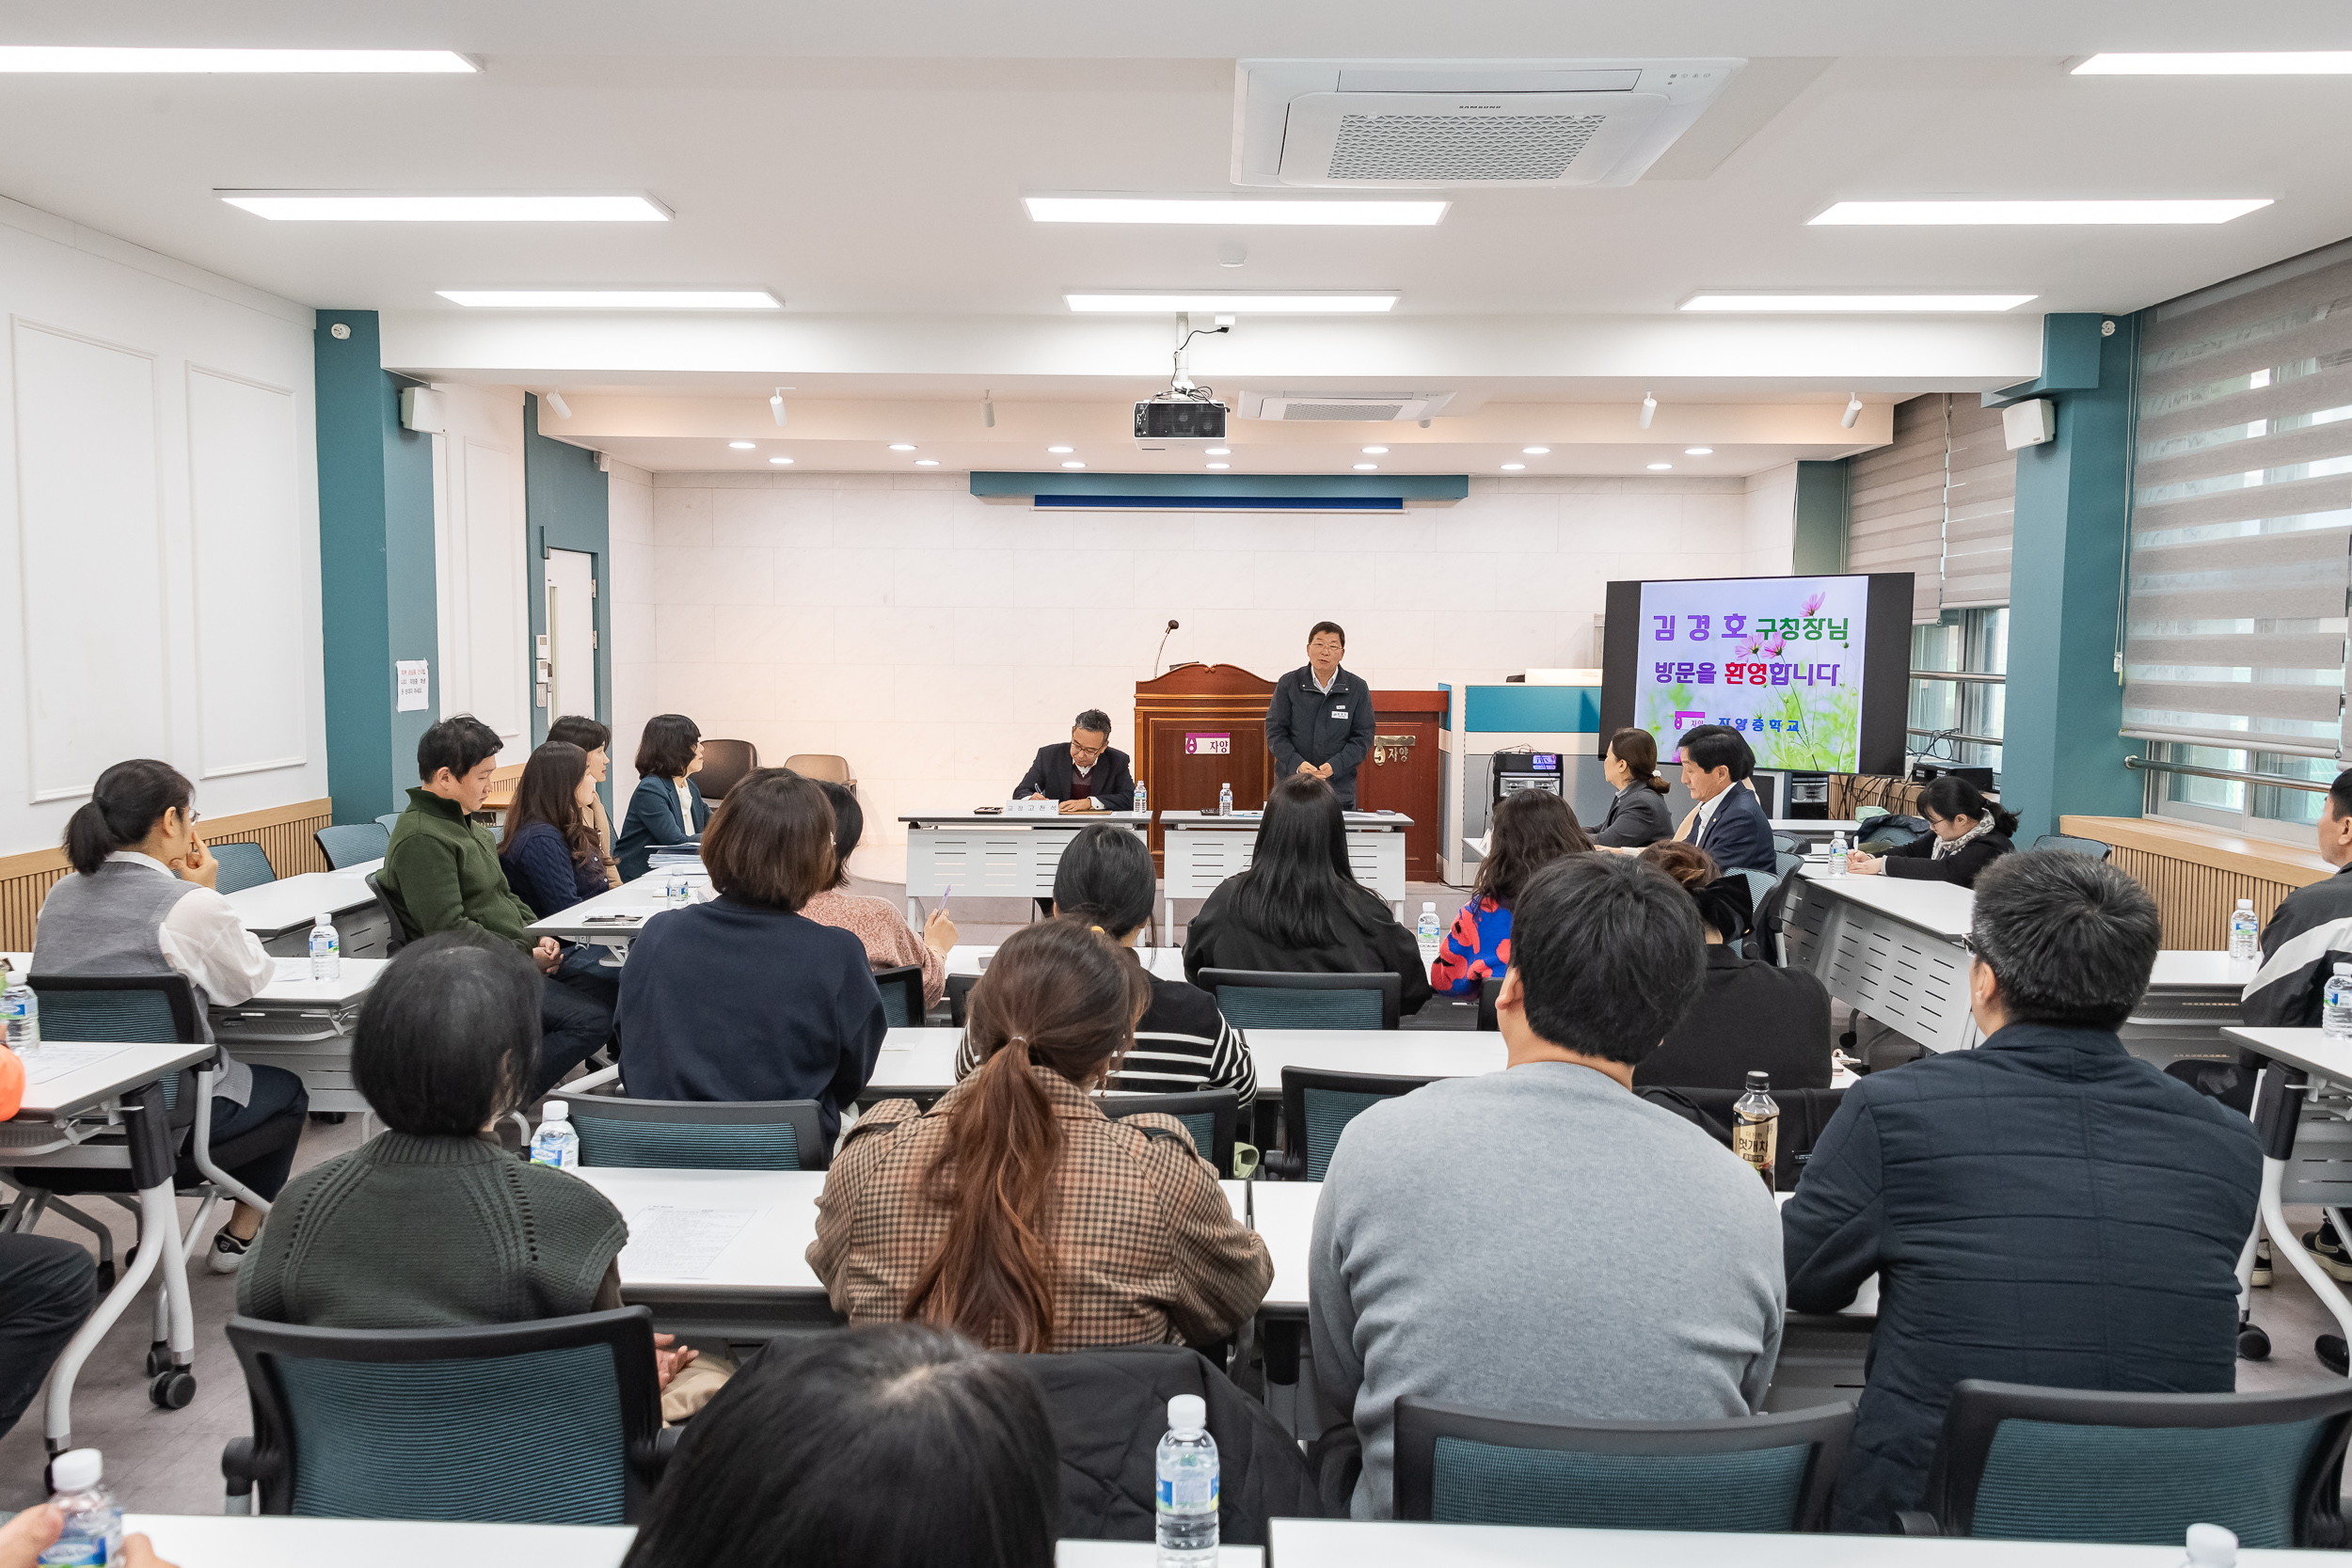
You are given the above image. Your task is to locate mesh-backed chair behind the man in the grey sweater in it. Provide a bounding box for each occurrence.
[1397,1397,1853,1535]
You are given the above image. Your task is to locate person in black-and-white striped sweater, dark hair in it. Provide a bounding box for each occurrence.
[955,823,1259,1112]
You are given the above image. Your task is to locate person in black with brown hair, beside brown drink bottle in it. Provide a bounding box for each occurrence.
[1637,839,1830,1088]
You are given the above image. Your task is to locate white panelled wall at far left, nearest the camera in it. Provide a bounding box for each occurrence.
[0,199,327,853]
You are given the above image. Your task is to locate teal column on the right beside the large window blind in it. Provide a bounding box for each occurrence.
[2002,315,2143,847]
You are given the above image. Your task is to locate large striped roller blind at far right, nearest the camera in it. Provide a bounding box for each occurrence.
[2124,246,2352,757]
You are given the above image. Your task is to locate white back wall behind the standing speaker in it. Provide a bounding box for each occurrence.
[612,470,1795,875]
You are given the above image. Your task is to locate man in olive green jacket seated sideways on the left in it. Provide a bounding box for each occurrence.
[376,715,612,1101]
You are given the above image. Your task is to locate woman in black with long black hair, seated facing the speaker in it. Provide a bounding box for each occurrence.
[1184,773,1430,1013]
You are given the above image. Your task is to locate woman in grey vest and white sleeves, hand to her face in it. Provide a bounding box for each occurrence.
[33,759,310,1275]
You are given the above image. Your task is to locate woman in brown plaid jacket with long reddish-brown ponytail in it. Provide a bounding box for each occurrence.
[809,919,1275,1352]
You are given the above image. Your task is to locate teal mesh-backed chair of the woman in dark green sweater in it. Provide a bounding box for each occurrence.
[221,1307,677,1524]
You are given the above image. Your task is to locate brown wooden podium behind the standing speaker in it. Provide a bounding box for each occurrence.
[1136,665,1447,881]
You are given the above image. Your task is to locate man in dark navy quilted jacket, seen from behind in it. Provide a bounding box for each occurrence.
[1781,851,2263,1530]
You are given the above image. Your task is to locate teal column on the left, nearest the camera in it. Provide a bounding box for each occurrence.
[313,310,440,823]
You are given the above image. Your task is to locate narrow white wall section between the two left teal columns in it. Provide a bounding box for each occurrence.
[433,383,534,764]
